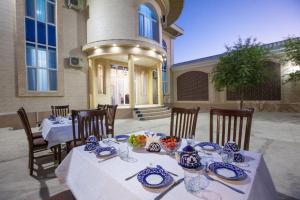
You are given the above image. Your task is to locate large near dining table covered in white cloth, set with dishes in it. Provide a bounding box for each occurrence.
[55,131,277,200]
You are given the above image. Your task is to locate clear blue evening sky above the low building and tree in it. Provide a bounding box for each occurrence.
[174,0,300,63]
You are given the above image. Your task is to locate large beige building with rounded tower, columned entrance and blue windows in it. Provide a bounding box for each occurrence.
[0,0,183,127]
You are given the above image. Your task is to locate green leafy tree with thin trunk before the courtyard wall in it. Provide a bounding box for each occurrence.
[212,38,269,109]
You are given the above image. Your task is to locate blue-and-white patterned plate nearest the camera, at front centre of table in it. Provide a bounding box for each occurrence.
[137,166,173,188]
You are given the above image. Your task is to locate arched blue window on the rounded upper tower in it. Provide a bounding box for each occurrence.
[139,4,159,42]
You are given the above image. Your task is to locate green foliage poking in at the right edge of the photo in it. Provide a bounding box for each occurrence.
[284,38,300,83]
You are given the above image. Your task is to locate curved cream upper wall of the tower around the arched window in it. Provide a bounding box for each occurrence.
[87,0,162,43]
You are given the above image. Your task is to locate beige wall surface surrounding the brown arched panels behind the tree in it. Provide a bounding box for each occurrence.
[172,61,300,112]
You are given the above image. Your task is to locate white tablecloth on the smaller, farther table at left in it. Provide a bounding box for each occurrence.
[40,118,77,148]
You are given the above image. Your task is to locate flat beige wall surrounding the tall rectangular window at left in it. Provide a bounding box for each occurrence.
[0,0,87,115]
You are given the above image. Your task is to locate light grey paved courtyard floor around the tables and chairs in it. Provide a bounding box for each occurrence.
[0,113,300,200]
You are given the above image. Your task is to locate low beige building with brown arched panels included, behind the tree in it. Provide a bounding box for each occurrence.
[172,41,300,112]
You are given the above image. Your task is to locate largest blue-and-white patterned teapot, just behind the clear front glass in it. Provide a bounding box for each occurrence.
[179,145,201,169]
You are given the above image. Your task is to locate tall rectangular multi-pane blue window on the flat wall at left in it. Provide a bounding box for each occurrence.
[25,0,57,92]
